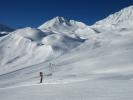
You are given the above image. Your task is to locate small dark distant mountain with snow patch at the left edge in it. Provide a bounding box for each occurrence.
[0,24,14,37]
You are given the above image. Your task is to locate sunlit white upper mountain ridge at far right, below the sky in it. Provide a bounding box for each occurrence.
[95,5,133,28]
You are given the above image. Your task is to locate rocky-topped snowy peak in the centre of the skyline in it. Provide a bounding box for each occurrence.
[38,16,86,33]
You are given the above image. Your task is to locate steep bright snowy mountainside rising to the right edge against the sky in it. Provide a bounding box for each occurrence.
[93,6,133,30]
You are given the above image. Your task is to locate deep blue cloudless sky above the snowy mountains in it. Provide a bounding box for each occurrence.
[0,0,133,28]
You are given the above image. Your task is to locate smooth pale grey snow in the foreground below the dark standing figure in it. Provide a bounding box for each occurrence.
[0,80,133,100]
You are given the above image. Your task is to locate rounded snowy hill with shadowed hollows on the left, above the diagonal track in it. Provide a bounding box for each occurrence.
[0,27,84,74]
